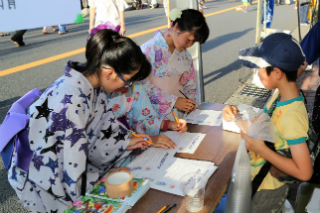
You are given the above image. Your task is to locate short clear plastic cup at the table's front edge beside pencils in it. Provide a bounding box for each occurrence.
[180,172,208,212]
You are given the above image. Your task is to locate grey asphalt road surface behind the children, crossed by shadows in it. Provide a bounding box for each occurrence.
[0,0,297,213]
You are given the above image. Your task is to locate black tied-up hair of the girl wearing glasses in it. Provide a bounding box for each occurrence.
[69,29,152,81]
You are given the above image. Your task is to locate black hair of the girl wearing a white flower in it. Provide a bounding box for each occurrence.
[173,9,210,44]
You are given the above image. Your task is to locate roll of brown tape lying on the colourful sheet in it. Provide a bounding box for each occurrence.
[105,171,133,198]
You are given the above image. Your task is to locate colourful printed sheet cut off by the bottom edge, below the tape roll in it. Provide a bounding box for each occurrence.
[64,196,130,213]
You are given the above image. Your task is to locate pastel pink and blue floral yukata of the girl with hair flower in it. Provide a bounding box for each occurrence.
[141,31,197,121]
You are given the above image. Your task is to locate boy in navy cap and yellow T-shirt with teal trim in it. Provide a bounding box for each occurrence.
[223,33,313,213]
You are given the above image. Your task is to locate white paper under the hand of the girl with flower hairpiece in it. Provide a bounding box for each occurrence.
[184,109,222,126]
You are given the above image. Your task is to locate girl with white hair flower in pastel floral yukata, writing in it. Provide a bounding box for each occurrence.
[141,9,209,120]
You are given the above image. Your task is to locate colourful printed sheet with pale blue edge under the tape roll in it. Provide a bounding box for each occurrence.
[86,177,150,206]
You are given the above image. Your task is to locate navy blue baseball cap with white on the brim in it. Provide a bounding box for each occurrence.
[239,33,305,71]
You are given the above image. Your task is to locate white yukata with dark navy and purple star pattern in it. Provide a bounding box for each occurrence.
[8,60,130,213]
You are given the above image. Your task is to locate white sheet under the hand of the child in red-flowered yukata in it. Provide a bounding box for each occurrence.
[164,131,206,154]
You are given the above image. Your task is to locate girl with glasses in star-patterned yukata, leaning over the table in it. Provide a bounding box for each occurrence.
[8,29,156,213]
